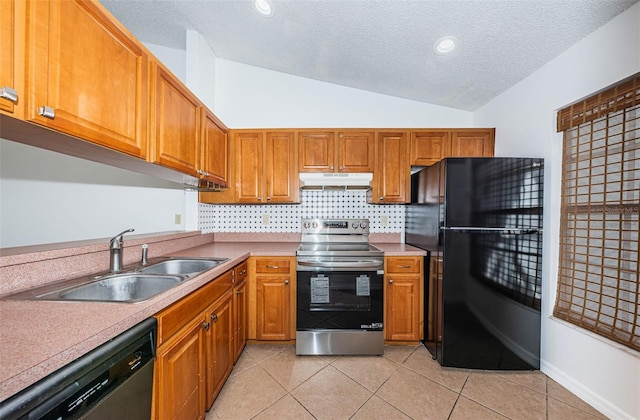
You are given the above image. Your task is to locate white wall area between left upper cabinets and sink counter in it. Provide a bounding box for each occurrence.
[0,139,185,248]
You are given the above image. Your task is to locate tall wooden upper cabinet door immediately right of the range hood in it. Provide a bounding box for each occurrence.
[371,132,411,203]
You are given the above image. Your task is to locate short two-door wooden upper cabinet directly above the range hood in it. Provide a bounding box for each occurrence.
[298,130,375,173]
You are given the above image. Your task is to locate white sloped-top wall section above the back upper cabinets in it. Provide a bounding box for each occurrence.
[215,59,472,128]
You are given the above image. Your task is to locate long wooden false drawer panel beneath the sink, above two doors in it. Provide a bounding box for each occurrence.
[156,271,233,346]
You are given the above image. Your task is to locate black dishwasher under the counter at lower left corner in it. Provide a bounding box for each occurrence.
[0,318,157,420]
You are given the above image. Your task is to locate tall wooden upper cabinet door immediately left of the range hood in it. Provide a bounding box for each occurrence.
[264,131,300,203]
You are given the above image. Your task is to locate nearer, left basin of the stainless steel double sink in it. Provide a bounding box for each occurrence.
[52,274,185,302]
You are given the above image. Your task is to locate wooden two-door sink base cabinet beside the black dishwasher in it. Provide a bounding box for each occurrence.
[153,270,236,420]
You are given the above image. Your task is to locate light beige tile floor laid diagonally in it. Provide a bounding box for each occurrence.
[206,344,605,420]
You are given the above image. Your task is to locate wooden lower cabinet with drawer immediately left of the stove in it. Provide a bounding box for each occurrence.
[249,257,295,341]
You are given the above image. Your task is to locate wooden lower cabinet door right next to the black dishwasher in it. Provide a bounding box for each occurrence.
[154,316,205,420]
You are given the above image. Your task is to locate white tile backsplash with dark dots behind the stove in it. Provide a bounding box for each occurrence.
[198,190,404,233]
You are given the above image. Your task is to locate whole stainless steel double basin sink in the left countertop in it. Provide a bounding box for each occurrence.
[7,257,228,303]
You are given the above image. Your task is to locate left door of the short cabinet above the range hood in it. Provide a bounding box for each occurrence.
[298,132,335,172]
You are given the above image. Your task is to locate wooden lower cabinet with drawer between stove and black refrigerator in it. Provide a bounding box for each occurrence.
[384,257,424,342]
